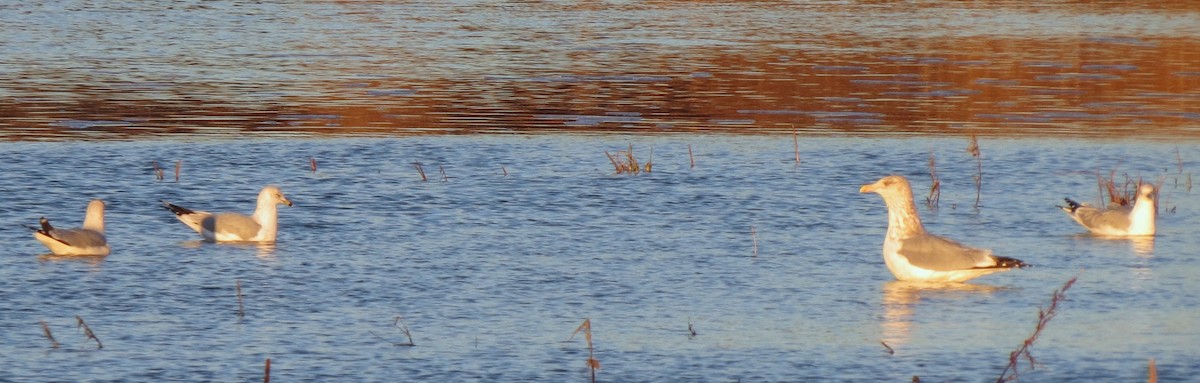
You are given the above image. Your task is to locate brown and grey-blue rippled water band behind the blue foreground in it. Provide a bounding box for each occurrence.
[0,1,1200,140]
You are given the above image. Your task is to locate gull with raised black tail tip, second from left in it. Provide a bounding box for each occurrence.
[162,186,292,243]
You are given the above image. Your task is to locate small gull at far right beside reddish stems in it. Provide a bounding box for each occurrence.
[1058,184,1158,237]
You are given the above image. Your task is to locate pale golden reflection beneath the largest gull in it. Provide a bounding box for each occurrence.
[881,281,1003,349]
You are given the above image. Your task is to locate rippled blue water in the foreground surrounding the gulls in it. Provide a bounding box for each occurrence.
[0,134,1200,382]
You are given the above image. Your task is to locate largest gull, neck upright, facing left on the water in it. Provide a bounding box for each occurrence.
[858,175,1027,282]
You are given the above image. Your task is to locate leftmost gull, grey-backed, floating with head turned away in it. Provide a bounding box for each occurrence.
[29,199,109,256]
